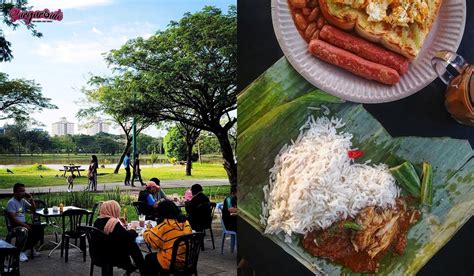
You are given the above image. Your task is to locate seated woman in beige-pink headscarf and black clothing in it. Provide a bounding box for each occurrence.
[94,200,144,273]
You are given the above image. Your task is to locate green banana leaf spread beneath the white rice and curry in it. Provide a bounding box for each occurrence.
[237,58,474,275]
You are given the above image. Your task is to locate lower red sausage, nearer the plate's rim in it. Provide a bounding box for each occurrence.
[308,39,400,85]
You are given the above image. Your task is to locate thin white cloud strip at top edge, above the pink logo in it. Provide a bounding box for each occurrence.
[28,0,112,10]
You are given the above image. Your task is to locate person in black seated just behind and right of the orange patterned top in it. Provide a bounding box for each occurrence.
[186,184,211,231]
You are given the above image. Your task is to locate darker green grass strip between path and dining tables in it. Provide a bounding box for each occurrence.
[0,186,229,237]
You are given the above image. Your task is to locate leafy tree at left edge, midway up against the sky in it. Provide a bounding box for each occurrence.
[0,73,57,121]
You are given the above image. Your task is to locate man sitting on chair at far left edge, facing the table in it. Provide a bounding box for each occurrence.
[7,183,44,262]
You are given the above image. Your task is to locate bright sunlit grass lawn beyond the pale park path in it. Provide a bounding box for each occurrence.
[0,163,227,188]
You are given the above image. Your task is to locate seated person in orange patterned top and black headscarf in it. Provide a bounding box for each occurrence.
[143,200,192,275]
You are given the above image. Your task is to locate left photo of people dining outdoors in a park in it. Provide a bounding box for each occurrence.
[0,0,237,275]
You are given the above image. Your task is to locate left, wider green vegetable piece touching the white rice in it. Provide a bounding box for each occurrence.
[390,161,420,197]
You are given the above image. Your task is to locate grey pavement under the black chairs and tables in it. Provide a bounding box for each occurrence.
[20,217,237,276]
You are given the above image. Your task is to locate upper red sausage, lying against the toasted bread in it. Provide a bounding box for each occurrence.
[319,25,409,75]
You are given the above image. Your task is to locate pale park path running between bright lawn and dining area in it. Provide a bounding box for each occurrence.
[0,179,229,195]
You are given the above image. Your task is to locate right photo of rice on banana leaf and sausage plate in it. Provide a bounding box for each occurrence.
[237,0,474,275]
